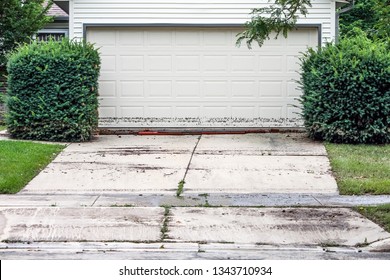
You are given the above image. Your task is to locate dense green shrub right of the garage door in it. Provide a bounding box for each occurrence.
[300,32,390,143]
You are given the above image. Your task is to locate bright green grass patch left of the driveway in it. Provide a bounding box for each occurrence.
[0,141,64,194]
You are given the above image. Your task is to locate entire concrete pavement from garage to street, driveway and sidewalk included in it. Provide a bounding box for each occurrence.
[0,134,390,259]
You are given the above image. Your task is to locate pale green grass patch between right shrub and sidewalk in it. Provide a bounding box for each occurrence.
[325,143,390,195]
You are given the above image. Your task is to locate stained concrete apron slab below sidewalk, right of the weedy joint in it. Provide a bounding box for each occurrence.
[168,207,390,246]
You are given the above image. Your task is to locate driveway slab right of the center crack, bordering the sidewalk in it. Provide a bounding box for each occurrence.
[184,154,338,194]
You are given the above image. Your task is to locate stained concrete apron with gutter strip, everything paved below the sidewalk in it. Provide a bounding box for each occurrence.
[0,207,390,260]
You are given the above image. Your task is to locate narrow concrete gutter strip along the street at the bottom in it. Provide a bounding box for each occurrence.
[0,242,390,260]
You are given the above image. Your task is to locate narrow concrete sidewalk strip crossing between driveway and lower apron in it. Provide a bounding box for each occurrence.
[0,193,390,207]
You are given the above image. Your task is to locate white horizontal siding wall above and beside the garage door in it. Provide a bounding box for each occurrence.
[69,0,336,44]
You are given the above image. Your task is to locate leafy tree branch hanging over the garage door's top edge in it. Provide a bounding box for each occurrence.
[237,0,311,48]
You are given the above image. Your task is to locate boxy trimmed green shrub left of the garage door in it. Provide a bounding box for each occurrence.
[6,39,100,141]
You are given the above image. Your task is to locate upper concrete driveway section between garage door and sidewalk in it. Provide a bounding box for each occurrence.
[22,134,337,195]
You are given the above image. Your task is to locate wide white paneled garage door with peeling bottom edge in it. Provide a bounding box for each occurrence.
[87,27,318,127]
